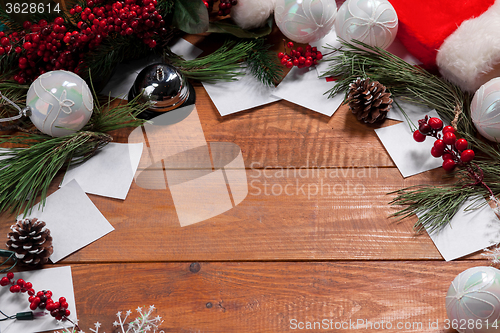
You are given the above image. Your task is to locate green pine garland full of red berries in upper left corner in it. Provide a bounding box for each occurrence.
[0,0,283,216]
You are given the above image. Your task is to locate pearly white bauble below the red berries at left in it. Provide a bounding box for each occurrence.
[26,70,94,137]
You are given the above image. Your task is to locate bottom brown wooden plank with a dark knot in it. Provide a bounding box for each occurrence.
[67,261,481,333]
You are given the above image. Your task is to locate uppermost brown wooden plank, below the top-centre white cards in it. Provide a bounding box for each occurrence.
[108,85,398,167]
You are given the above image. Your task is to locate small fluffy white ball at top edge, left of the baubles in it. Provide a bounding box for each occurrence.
[231,0,276,29]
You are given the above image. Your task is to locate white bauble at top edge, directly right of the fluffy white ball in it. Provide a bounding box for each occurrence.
[274,0,337,43]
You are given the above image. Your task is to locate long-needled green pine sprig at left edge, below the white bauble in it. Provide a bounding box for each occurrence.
[0,131,111,216]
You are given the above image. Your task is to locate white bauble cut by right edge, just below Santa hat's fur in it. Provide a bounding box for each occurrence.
[470,77,500,142]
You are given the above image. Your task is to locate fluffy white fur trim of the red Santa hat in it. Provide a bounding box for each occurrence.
[436,0,500,92]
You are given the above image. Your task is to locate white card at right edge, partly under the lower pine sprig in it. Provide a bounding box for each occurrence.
[422,198,500,261]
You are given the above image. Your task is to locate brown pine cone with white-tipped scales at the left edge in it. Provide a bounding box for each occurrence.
[6,218,53,266]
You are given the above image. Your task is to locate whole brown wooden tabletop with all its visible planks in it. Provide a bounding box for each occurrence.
[0,59,488,333]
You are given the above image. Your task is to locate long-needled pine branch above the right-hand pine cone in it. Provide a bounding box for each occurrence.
[323,40,474,134]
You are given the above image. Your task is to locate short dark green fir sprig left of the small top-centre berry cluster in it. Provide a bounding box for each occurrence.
[246,39,283,87]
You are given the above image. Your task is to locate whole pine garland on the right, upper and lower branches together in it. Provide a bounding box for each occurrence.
[324,40,500,231]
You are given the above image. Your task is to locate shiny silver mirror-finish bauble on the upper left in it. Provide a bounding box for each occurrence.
[128,63,195,119]
